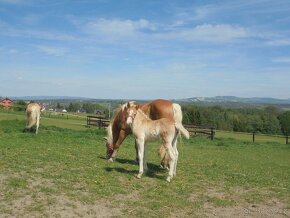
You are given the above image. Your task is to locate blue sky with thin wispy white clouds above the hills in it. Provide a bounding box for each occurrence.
[0,0,290,99]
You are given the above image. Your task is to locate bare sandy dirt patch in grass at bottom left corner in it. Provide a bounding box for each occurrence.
[0,194,121,218]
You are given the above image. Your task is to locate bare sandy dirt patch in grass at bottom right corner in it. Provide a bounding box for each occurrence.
[189,187,290,218]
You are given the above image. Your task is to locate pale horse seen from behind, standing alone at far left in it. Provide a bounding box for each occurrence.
[23,103,45,134]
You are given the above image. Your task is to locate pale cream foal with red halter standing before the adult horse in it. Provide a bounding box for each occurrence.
[126,103,189,182]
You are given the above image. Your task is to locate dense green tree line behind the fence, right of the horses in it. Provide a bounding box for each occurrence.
[183,106,290,135]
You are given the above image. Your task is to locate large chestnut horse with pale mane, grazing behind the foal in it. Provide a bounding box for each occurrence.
[106,99,182,161]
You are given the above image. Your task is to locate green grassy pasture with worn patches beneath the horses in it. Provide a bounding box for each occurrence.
[0,113,290,217]
